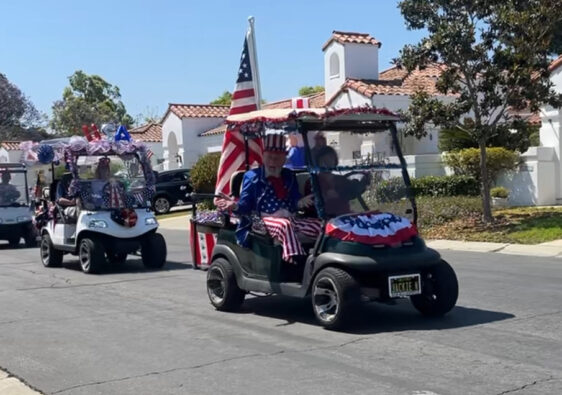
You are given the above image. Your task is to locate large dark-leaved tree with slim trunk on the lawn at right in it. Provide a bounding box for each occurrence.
[399,0,562,222]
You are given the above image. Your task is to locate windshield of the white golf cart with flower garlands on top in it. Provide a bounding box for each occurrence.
[76,154,151,210]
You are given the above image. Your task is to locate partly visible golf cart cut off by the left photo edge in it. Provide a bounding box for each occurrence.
[0,163,37,247]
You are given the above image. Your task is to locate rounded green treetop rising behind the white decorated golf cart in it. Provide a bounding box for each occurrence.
[51,70,133,135]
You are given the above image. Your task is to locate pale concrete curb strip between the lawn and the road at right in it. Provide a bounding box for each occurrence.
[426,240,562,258]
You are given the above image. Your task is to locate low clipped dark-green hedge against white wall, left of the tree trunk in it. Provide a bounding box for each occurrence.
[411,175,480,196]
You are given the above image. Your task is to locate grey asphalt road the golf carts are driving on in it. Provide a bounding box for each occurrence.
[0,230,562,395]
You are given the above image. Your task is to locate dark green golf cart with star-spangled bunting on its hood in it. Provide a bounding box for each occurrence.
[191,108,458,329]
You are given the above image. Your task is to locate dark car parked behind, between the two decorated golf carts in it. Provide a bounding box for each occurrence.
[152,169,193,214]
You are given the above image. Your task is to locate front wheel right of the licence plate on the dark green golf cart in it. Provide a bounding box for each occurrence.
[410,261,459,317]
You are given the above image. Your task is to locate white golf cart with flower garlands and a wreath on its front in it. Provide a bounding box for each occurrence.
[22,136,166,273]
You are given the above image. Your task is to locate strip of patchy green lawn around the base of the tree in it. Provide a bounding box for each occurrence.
[420,207,562,244]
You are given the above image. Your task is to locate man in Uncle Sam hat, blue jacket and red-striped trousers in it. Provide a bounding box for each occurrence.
[217,133,321,263]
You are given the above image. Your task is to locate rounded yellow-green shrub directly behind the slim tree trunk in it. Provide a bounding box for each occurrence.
[444,147,520,184]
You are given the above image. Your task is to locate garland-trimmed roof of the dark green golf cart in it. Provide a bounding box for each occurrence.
[226,107,401,131]
